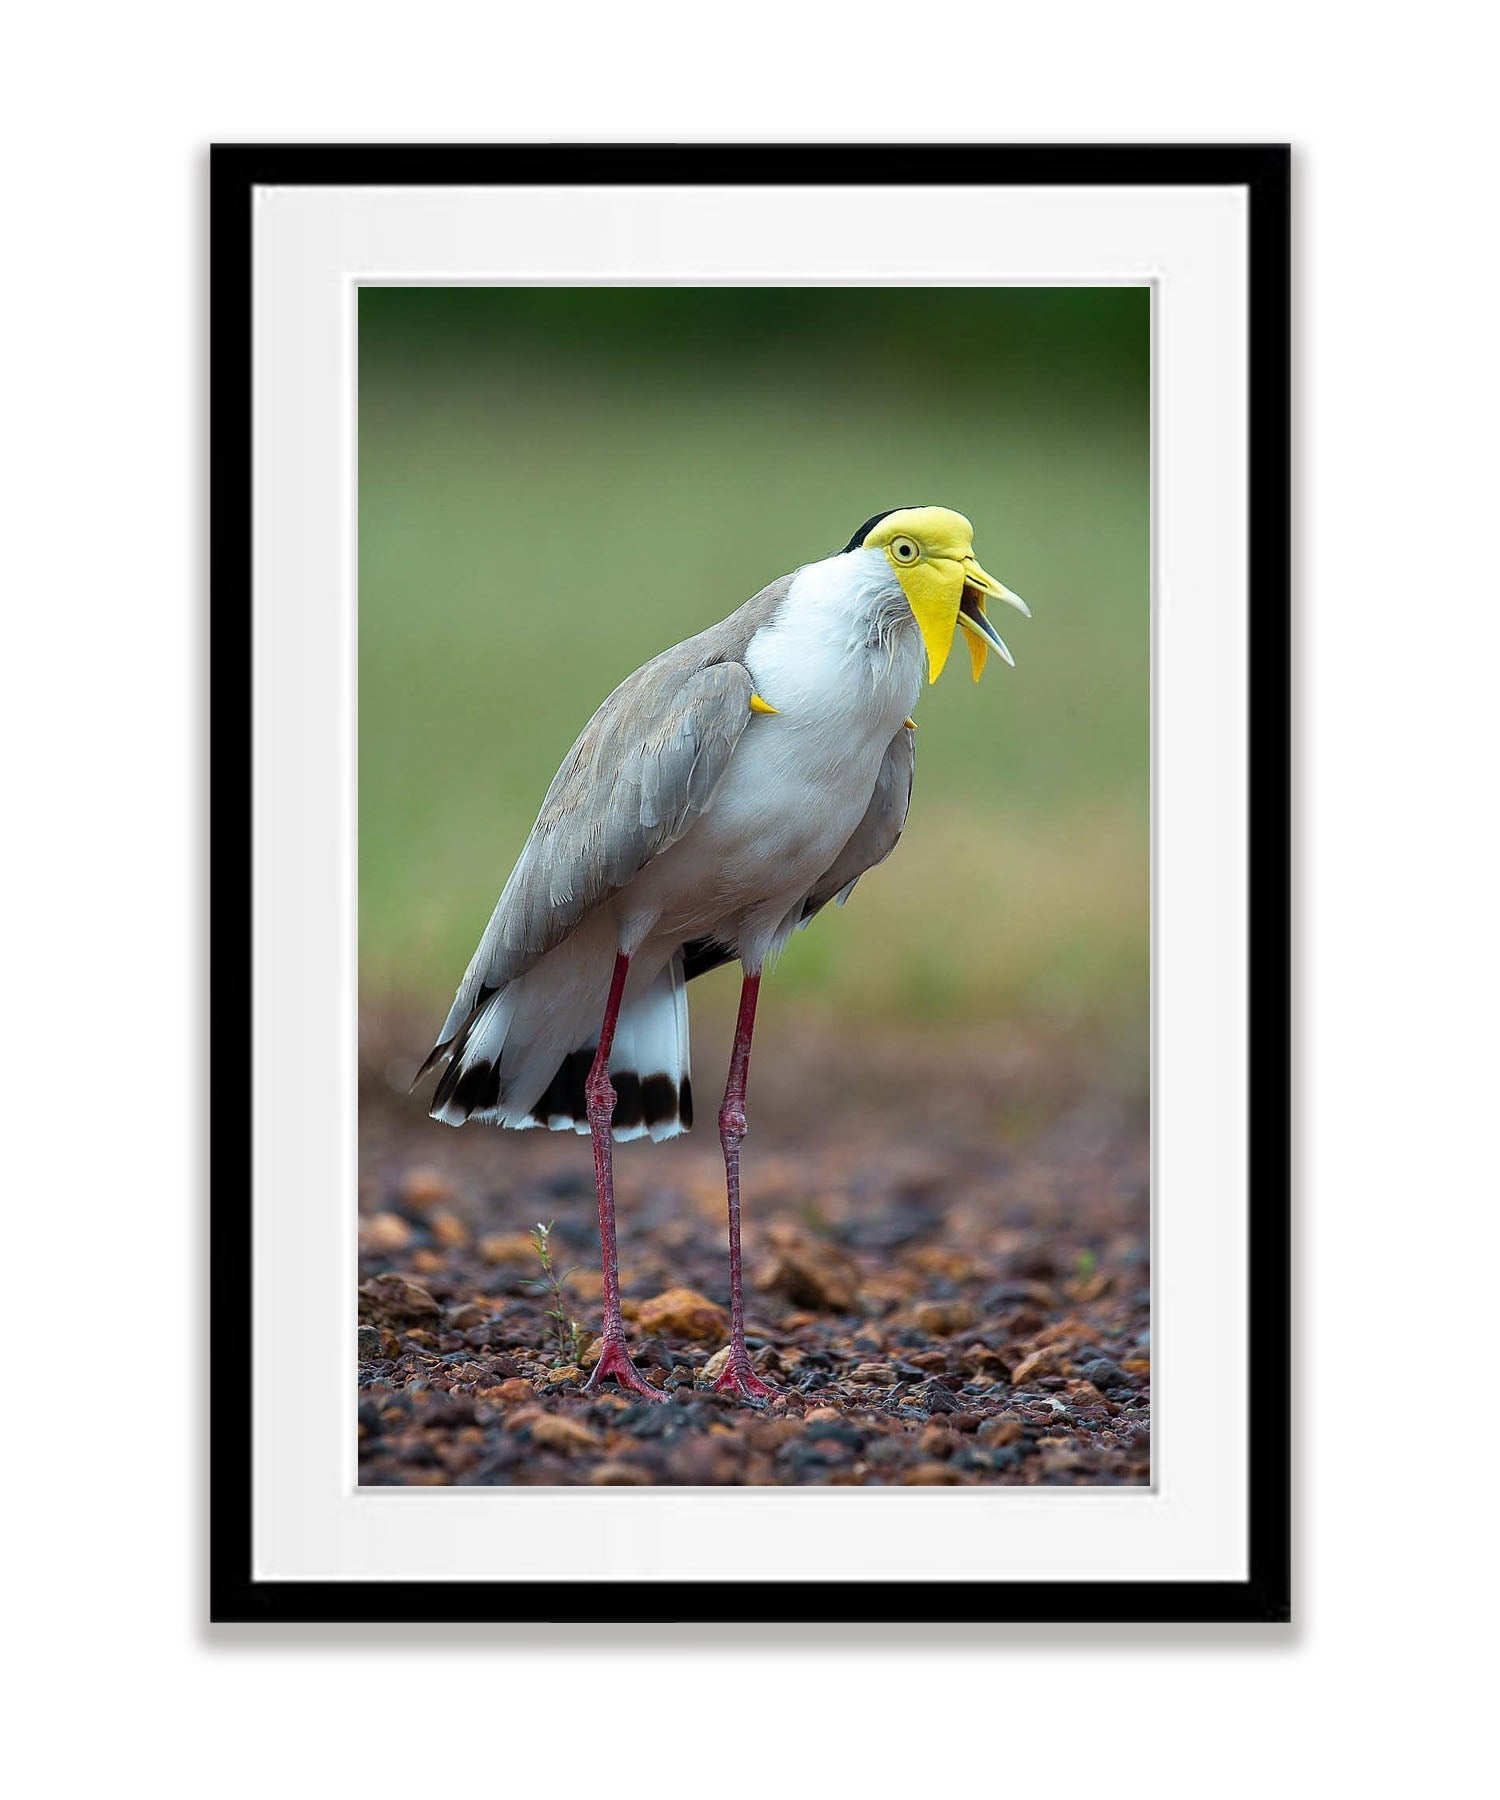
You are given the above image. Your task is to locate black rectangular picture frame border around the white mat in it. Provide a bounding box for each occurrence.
[209,144,1291,1624]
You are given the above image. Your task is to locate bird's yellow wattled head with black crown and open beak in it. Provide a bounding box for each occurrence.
[845,506,1032,680]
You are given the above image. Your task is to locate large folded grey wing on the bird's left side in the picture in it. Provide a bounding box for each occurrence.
[438,651,753,1046]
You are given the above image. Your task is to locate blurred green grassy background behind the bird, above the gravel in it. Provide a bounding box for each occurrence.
[358,288,1151,1084]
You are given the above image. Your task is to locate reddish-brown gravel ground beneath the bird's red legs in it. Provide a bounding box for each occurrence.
[358,1017,1151,1485]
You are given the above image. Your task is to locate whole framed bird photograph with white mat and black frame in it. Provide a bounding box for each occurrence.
[211,146,1289,1622]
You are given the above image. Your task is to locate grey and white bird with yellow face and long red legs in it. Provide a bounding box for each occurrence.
[412,506,1030,1406]
